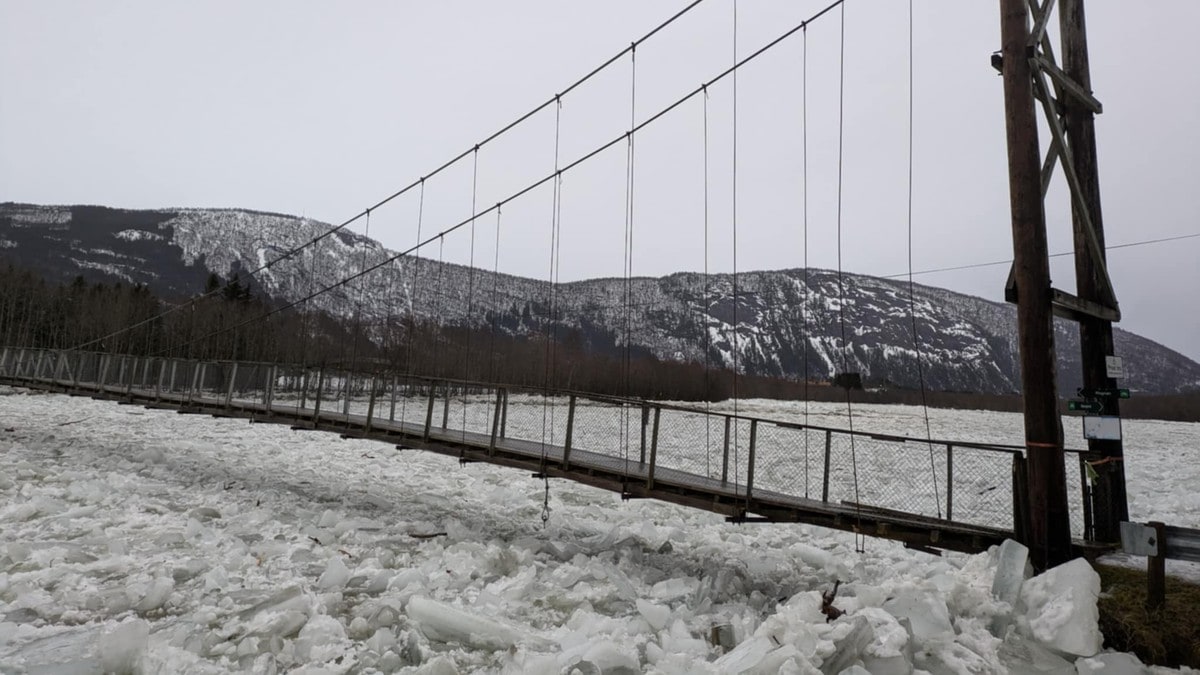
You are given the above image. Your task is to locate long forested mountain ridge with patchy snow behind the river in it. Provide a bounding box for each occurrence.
[7,203,1200,393]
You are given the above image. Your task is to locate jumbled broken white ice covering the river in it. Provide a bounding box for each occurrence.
[0,389,1200,675]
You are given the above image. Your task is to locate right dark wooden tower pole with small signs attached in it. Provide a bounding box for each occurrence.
[1058,0,1129,542]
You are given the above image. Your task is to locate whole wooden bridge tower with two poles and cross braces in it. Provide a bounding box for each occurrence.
[997,0,1127,568]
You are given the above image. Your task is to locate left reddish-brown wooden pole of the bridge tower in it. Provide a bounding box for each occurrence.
[1000,0,1070,569]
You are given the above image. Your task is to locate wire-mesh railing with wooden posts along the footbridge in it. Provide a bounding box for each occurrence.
[0,348,1091,537]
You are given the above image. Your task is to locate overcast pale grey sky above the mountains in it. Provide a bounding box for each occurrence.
[0,0,1200,358]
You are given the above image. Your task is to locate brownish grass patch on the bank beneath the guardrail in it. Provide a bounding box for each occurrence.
[1094,565,1200,668]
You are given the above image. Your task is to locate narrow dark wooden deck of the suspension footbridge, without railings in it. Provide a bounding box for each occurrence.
[0,374,1013,551]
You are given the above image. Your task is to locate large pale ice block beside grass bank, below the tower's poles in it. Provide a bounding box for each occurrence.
[1021,558,1104,656]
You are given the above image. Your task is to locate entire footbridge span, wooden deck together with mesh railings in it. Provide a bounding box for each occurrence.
[0,350,1104,552]
